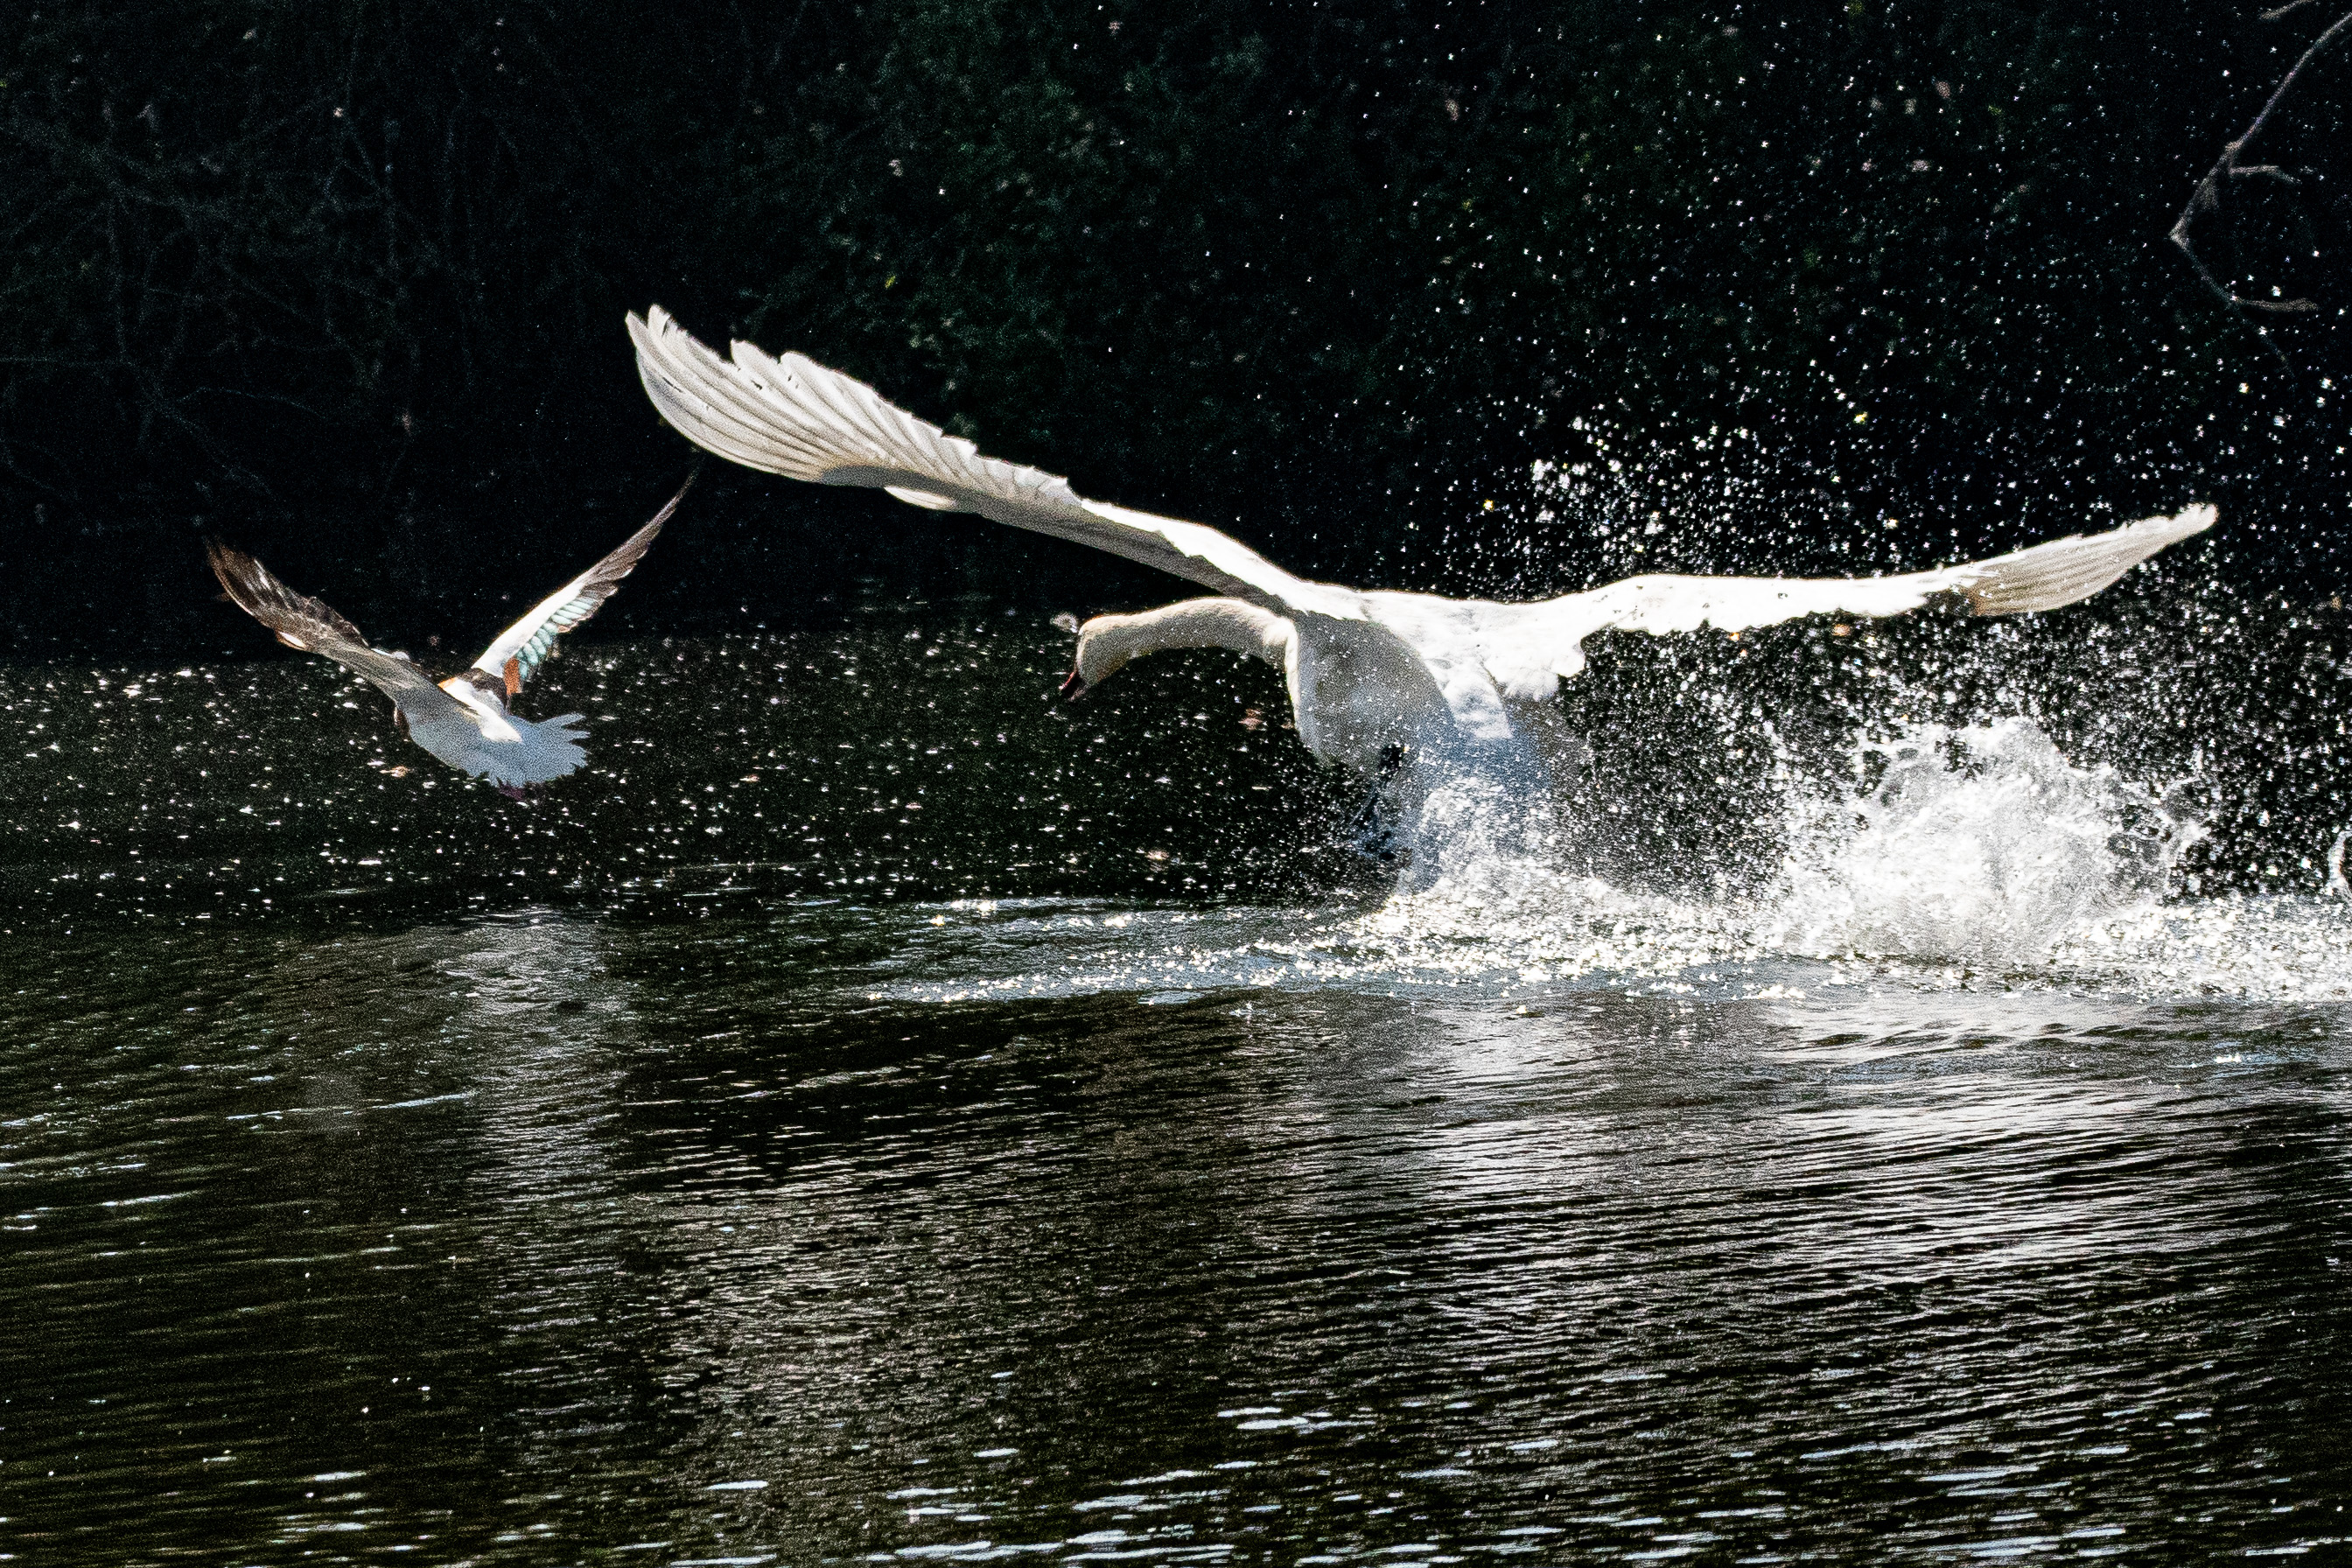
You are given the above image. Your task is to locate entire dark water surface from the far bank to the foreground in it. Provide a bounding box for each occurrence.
[13,619,2352,1564]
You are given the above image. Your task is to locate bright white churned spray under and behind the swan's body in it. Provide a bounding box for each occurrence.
[1350,717,2352,997]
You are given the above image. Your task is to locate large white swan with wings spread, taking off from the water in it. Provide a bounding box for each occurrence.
[628,305,2213,774]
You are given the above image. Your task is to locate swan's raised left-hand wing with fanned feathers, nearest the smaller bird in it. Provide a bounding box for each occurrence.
[628,305,1364,620]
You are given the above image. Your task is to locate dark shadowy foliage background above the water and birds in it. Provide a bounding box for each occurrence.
[0,0,2352,649]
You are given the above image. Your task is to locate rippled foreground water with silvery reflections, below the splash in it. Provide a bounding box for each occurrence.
[13,912,2352,1564]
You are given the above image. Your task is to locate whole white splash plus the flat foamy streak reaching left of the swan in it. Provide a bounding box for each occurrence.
[878,719,2352,999]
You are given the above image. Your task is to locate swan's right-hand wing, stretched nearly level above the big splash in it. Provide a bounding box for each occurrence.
[1481,506,2213,696]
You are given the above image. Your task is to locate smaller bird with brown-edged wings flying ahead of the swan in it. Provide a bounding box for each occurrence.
[205,475,694,799]
